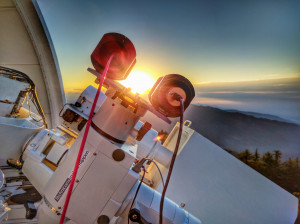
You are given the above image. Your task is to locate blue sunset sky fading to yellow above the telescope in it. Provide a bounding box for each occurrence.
[38,0,300,122]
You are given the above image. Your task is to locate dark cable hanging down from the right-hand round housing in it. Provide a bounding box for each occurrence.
[159,95,184,224]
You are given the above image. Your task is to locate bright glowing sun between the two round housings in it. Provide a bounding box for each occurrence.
[120,70,155,94]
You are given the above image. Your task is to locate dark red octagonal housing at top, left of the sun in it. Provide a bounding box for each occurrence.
[91,33,136,80]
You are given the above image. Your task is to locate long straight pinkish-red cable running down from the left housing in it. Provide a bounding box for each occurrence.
[59,55,114,224]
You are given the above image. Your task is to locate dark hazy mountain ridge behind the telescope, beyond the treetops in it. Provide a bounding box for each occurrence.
[142,105,300,160]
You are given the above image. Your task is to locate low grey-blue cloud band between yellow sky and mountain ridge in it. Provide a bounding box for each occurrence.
[193,77,300,123]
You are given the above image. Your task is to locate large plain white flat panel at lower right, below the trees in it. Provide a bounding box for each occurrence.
[159,132,298,224]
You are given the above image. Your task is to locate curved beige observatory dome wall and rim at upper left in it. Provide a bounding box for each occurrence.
[0,0,65,127]
